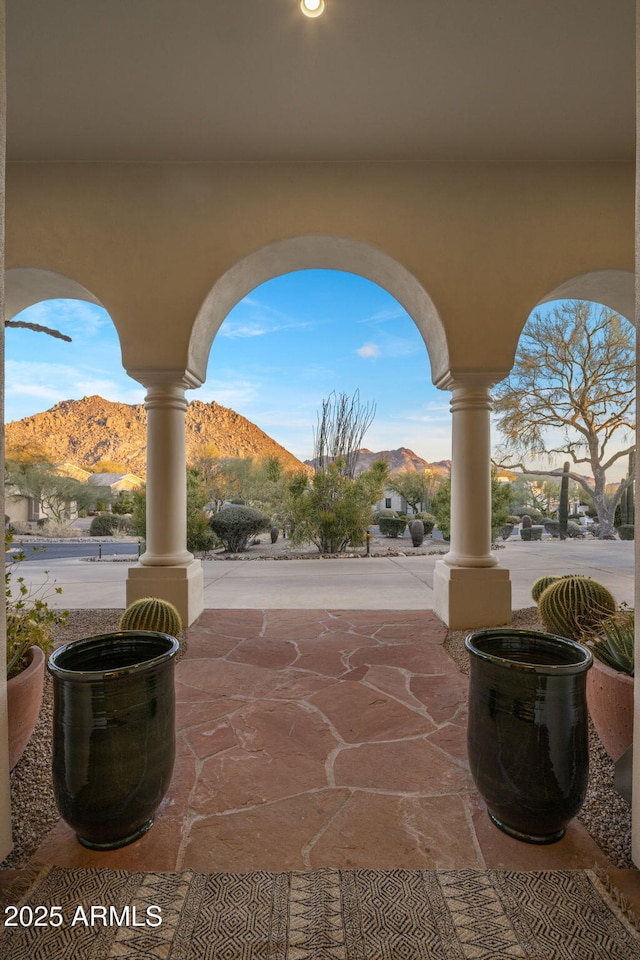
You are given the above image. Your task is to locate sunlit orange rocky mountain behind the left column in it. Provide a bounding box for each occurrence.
[5,396,302,477]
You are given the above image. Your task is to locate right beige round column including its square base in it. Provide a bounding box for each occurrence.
[434,374,511,629]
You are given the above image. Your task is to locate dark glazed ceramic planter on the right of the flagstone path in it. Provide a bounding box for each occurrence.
[466,628,593,843]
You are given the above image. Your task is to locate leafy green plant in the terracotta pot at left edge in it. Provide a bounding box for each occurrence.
[4,531,69,680]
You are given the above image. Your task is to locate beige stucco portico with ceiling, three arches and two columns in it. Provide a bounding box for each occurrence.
[0,0,640,859]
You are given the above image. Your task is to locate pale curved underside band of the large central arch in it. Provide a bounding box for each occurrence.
[188,235,449,383]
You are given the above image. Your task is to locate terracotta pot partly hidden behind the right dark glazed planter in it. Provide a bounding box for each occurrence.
[587,658,633,760]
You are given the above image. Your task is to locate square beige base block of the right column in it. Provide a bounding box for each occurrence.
[433,560,511,630]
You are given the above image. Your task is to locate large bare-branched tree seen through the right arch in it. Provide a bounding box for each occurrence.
[494,300,635,538]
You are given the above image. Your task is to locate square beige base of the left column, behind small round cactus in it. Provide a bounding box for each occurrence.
[126,560,204,627]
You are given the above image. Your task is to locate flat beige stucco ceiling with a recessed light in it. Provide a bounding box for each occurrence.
[7,0,635,161]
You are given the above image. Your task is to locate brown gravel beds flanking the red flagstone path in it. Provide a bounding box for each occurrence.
[0,607,633,870]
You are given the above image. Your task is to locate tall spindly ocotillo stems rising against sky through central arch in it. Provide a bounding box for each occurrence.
[313,390,376,478]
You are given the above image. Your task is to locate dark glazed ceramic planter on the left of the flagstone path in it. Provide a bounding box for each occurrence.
[48,630,179,850]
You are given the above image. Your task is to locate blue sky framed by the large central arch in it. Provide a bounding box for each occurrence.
[194,270,451,472]
